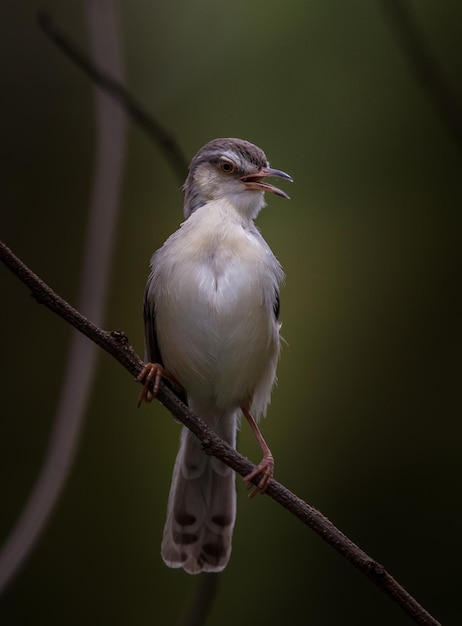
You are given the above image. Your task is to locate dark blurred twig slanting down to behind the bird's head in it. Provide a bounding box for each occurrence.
[37,12,189,184]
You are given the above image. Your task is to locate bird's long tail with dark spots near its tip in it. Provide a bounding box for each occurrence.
[161,414,237,574]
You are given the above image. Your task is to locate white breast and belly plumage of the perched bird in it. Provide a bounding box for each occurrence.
[150,203,283,414]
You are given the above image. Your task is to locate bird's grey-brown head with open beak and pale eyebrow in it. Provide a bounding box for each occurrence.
[183,138,292,219]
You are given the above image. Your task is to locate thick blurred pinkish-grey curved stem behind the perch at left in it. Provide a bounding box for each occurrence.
[0,0,127,593]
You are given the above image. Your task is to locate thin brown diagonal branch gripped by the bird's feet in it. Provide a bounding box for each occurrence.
[0,242,441,626]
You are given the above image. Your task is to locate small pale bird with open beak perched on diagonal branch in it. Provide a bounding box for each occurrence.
[138,138,292,574]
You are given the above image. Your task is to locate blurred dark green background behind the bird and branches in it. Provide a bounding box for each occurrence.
[0,0,462,626]
